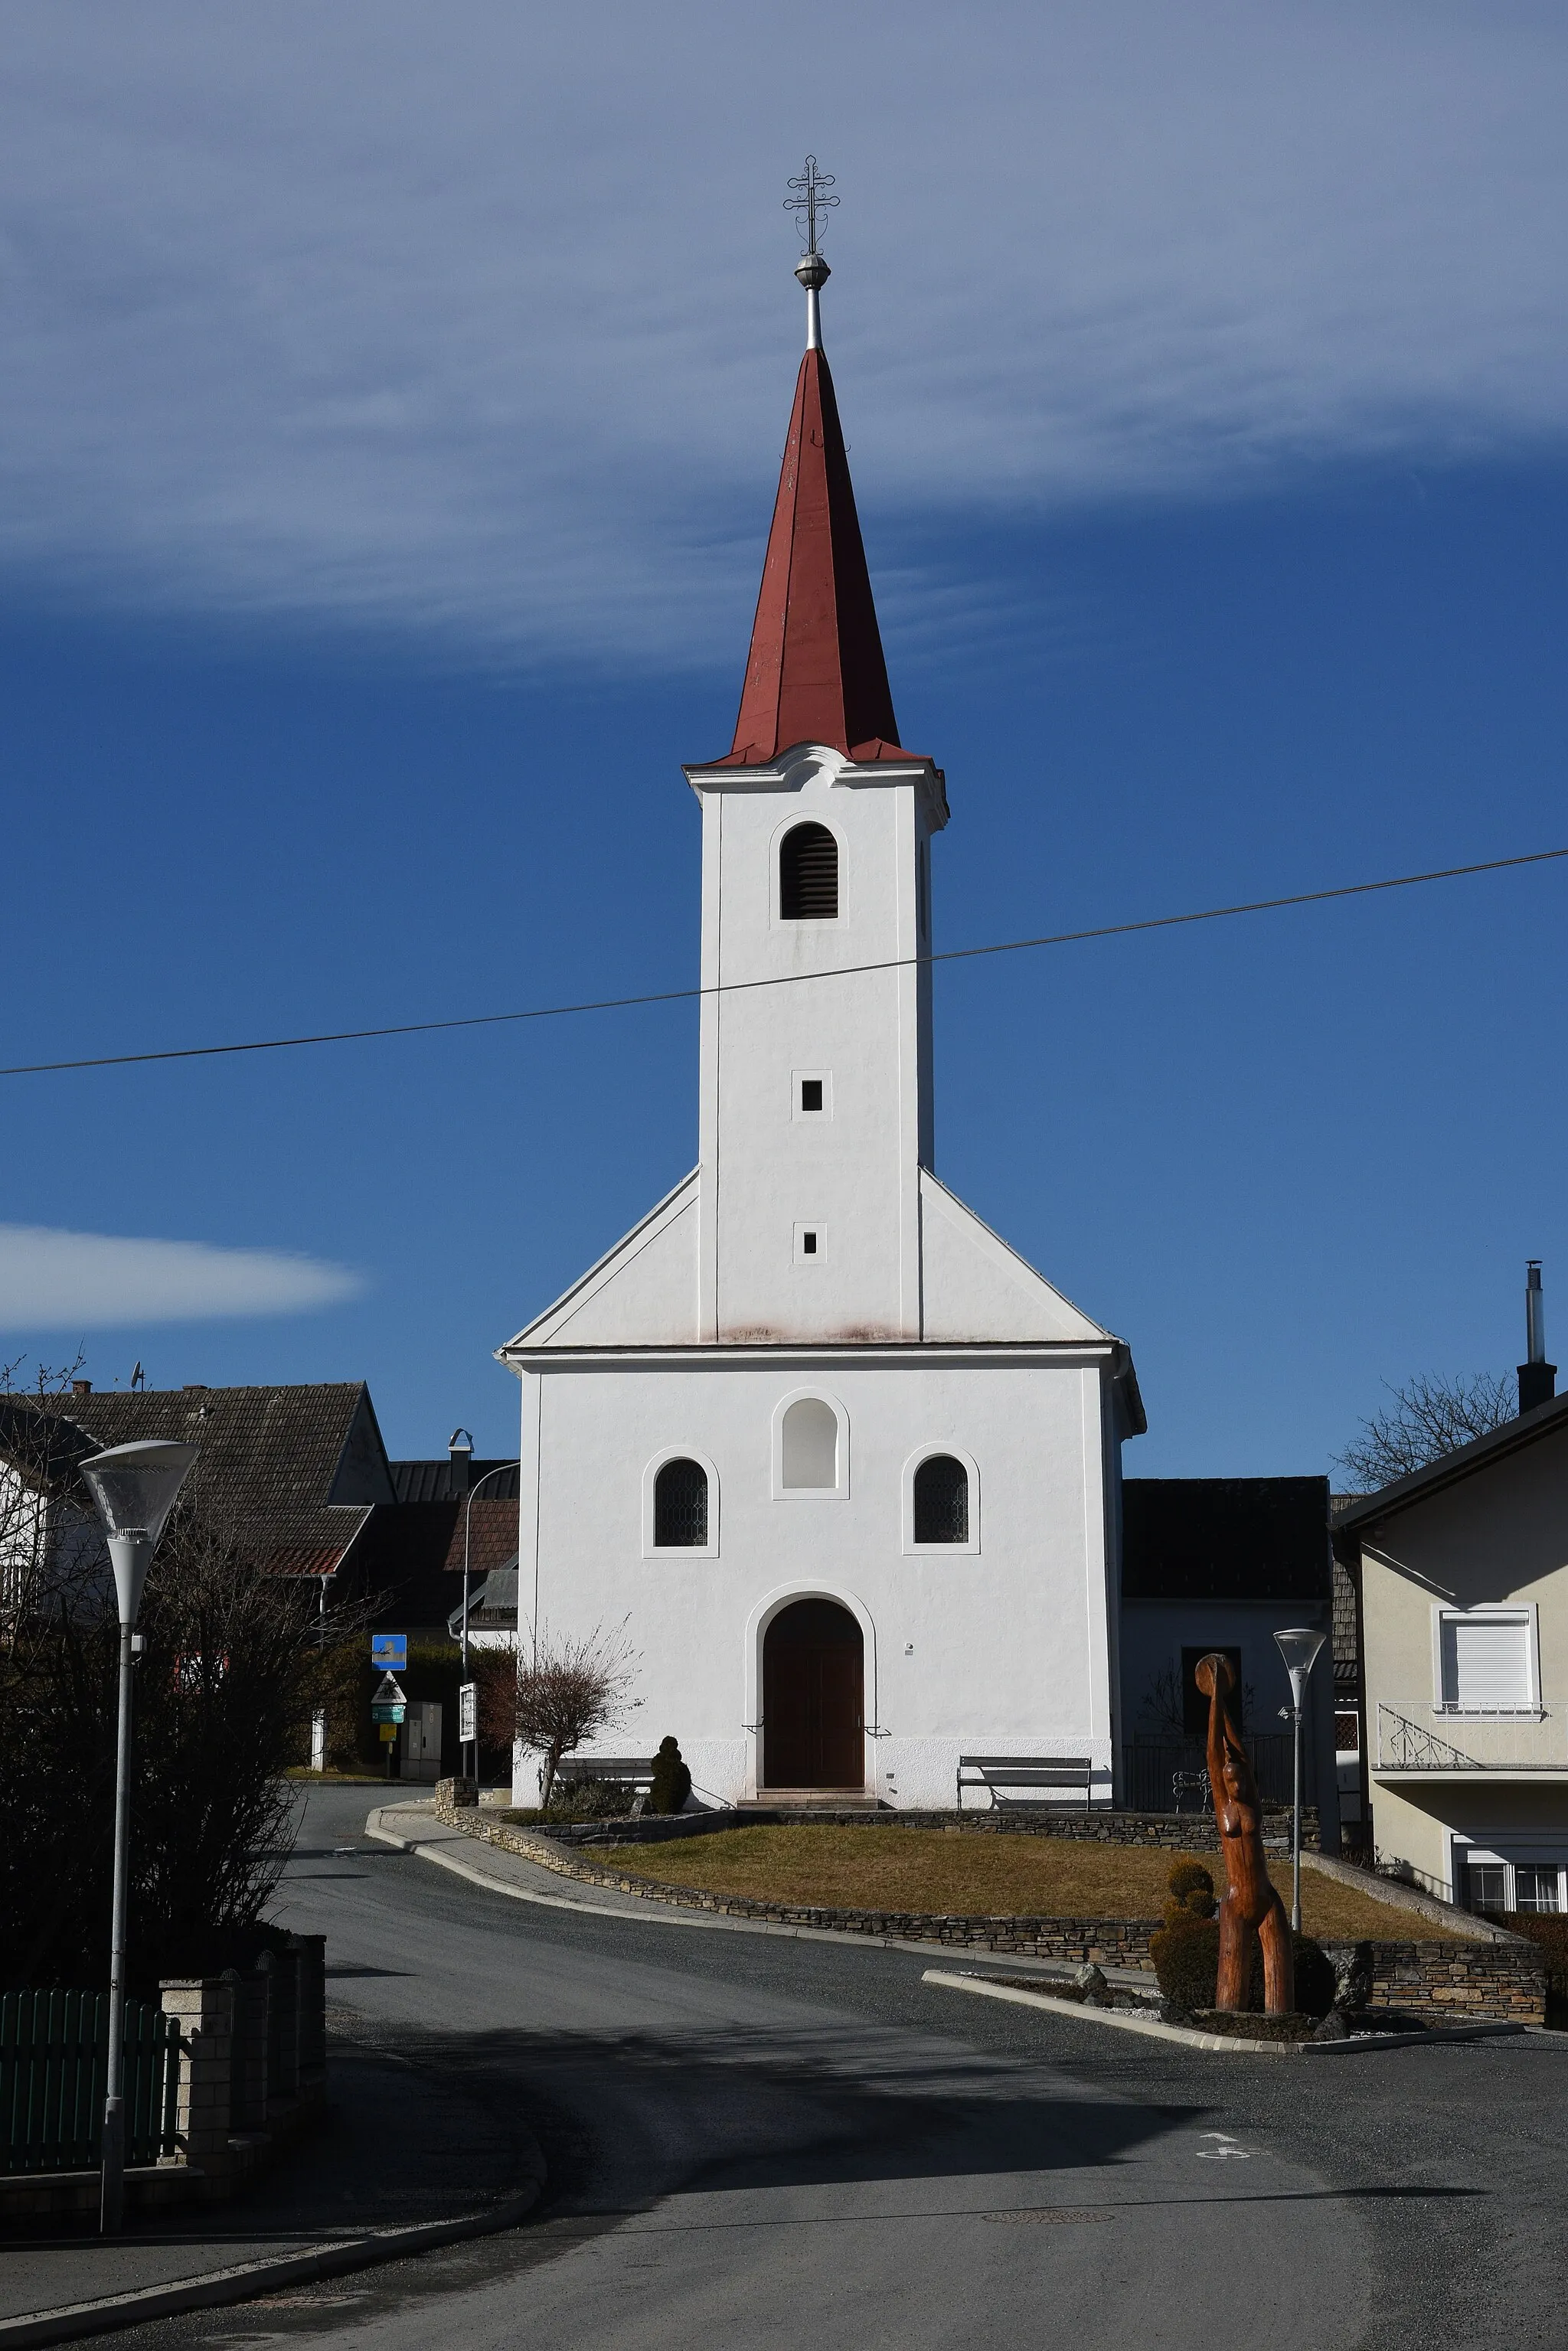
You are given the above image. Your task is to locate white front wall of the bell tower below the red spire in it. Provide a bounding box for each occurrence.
[701,753,929,1340]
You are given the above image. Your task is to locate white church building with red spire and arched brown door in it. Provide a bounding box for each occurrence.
[498,238,1145,1808]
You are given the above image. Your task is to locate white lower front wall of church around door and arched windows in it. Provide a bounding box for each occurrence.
[520,1357,1112,1806]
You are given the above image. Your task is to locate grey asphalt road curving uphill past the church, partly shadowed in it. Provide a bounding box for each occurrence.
[119,1789,1568,2351]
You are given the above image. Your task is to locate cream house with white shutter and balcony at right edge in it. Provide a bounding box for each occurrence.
[1335,1396,1568,1909]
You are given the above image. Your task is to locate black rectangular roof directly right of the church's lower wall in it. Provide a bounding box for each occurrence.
[1122,1477,1331,1605]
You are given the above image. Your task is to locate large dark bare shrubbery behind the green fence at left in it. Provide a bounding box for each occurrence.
[0,1392,369,1987]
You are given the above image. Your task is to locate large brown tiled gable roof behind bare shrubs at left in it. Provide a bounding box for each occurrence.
[0,1380,393,1575]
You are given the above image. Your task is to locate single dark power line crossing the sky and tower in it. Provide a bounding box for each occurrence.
[0,849,1568,1077]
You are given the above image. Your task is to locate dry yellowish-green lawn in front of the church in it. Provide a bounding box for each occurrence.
[616,1822,1446,1942]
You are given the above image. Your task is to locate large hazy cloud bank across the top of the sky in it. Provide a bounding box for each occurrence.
[0,0,1568,661]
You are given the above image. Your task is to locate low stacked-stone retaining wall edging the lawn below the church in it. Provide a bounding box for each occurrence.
[435,1780,1547,2024]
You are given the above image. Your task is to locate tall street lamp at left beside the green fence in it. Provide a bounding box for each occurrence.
[82,1438,195,2236]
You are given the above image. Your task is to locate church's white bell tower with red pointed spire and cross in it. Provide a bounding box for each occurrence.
[687,158,947,1343]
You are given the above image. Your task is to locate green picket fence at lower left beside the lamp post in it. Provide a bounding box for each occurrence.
[0,1991,178,2173]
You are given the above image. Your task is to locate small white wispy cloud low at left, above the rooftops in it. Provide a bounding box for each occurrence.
[0,1225,364,1333]
